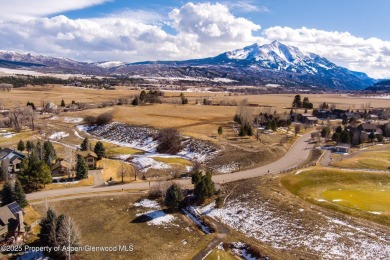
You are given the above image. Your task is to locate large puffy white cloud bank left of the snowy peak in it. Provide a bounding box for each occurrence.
[0,3,260,62]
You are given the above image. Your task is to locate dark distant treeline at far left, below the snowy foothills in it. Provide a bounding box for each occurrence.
[0,76,68,88]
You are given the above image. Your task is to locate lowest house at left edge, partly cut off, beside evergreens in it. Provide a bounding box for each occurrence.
[0,202,26,242]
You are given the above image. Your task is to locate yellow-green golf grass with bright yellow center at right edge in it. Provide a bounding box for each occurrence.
[281,168,390,225]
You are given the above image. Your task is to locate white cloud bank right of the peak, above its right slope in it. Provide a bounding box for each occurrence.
[263,26,390,78]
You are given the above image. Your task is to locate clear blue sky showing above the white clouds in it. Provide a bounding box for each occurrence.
[64,0,390,40]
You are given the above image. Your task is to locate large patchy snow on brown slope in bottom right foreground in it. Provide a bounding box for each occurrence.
[200,198,390,259]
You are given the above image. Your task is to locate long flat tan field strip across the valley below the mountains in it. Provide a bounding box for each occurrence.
[0,85,390,112]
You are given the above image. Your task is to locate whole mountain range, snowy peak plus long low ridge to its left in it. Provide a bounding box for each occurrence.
[0,41,376,90]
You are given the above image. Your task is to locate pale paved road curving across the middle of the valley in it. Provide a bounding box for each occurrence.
[27,133,314,200]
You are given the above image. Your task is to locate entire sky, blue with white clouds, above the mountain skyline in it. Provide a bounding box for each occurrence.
[0,0,390,78]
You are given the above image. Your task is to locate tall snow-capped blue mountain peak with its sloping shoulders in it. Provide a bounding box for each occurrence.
[127,41,376,90]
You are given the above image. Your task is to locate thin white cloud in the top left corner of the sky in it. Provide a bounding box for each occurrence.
[0,0,111,21]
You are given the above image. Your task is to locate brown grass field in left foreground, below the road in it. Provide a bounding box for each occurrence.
[34,195,213,259]
